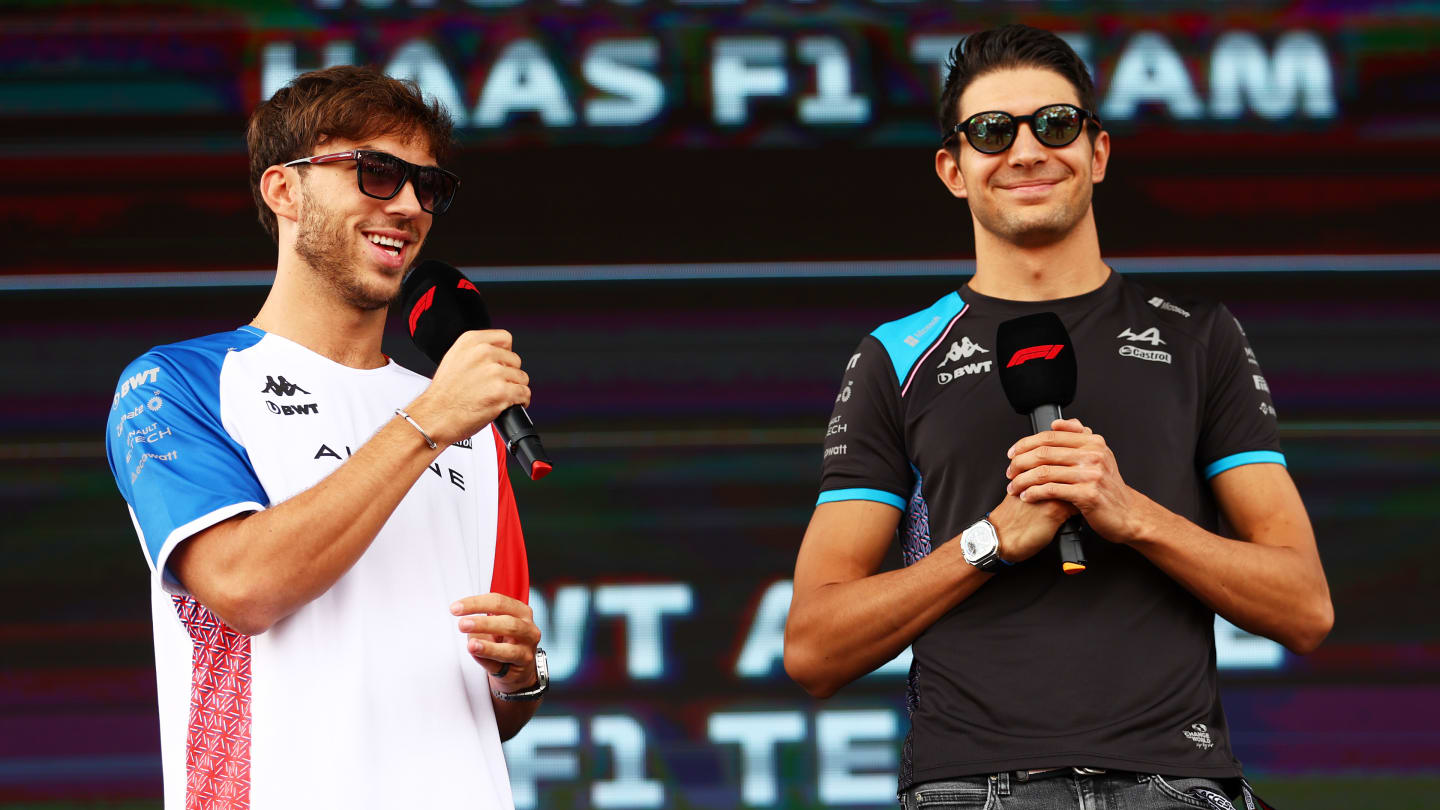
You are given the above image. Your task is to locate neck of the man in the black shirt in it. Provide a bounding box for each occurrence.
[969,209,1110,301]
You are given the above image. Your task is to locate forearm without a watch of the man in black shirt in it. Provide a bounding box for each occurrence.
[1123,484,1333,654]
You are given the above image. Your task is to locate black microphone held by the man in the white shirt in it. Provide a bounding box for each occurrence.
[400,259,554,481]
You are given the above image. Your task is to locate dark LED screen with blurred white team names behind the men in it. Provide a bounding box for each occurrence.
[0,0,1440,807]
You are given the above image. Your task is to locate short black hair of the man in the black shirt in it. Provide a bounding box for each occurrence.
[939,25,1096,138]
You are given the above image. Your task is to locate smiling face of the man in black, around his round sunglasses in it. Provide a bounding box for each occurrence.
[936,68,1109,246]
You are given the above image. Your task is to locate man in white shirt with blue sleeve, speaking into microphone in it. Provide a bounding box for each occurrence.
[107,66,547,809]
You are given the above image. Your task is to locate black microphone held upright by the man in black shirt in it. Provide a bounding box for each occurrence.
[995,313,1087,574]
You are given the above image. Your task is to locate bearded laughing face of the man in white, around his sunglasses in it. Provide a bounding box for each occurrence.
[294,135,435,310]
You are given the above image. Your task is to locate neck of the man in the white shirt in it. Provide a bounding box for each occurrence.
[251,251,389,369]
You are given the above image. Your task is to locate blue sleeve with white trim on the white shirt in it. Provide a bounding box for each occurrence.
[105,344,269,592]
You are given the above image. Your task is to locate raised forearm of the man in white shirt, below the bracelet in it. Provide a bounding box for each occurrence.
[173,409,442,634]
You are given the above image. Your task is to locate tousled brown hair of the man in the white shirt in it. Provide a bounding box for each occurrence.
[245,65,455,242]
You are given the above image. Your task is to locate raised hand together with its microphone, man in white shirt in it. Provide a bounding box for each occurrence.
[400,259,553,480]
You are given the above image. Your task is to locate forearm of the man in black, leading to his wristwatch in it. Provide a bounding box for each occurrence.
[785,543,991,698]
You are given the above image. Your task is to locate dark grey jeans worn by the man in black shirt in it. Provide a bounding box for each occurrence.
[900,771,1228,810]
